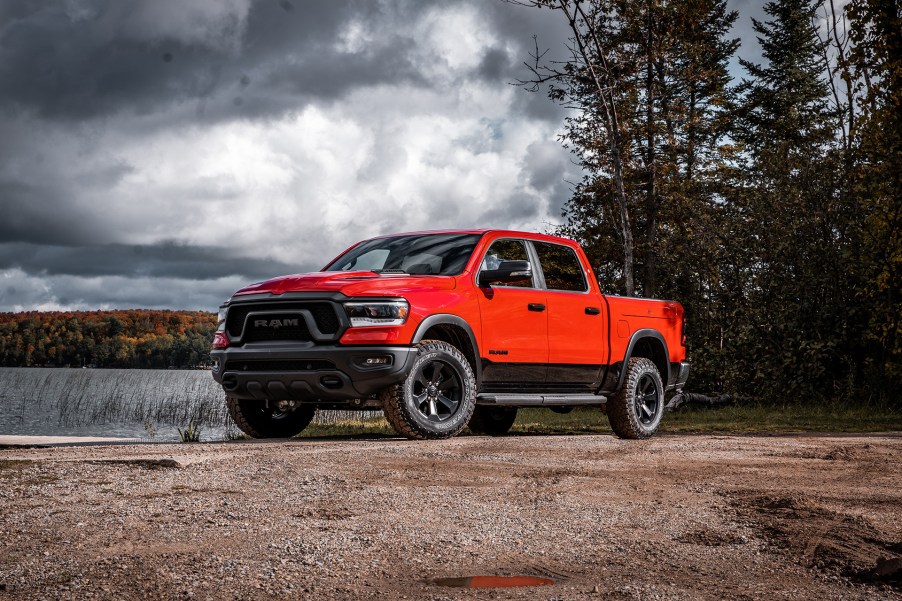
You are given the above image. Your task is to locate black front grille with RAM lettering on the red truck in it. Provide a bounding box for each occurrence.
[226,301,341,342]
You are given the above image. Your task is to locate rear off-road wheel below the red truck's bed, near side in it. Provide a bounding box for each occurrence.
[607,357,664,439]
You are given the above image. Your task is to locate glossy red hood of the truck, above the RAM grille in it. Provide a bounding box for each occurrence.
[234,271,455,296]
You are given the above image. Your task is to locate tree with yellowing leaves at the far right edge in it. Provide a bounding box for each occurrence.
[848,0,902,390]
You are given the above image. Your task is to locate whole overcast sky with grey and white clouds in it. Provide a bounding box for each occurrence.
[0,0,761,311]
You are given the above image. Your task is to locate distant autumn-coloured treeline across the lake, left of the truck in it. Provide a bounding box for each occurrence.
[0,309,216,368]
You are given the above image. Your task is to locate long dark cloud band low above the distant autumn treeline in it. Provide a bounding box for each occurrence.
[0,243,310,281]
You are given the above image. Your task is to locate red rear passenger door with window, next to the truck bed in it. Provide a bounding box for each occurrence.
[531,241,608,389]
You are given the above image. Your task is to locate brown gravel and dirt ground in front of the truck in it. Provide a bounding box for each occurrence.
[0,435,902,601]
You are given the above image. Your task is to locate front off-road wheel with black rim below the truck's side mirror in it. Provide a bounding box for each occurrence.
[381,340,476,440]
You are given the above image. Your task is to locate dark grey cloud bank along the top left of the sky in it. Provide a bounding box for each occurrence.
[0,0,444,120]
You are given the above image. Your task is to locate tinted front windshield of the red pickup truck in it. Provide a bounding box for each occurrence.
[323,234,481,275]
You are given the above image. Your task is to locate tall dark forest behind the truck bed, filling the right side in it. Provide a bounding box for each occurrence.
[507,0,902,407]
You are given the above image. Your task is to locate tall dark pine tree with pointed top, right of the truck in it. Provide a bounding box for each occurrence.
[730,0,850,398]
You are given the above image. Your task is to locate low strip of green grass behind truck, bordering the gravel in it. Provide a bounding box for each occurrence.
[299,402,902,438]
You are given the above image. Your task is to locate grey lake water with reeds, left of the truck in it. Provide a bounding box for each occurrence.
[0,367,375,441]
